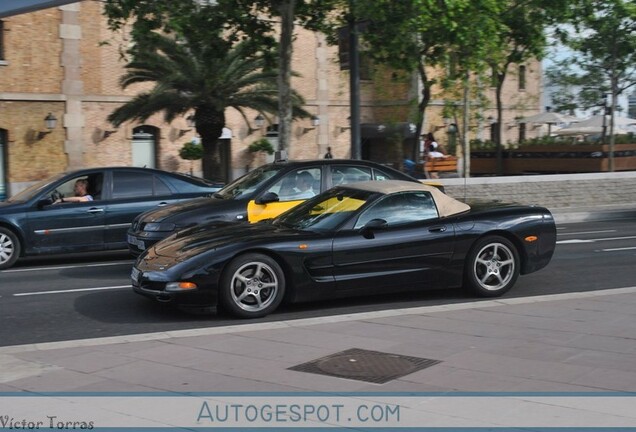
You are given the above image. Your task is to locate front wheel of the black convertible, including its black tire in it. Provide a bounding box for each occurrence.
[219,253,285,318]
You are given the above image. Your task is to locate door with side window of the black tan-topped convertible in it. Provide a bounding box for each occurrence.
[333,191,454,292]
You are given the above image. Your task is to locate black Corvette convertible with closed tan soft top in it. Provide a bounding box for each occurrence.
[132,181,556,318]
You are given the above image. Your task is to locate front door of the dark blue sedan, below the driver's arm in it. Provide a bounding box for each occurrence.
[27,171,106,253]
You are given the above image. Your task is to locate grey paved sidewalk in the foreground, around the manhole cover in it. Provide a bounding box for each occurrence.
[0,287,636,392]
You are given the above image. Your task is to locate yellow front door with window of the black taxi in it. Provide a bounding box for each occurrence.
[247,167,322,222]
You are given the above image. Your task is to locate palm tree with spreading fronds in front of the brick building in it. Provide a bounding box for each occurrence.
[108,32,308,181]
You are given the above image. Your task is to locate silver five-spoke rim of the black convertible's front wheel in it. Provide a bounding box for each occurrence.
[230,261,280,312]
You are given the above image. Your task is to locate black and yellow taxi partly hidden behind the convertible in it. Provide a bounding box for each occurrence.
[128,159,432,256]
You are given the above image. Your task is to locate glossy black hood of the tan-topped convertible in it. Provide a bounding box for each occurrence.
[149,222,303,262]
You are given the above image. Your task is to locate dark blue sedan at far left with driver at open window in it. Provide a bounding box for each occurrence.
[0,167,223,270]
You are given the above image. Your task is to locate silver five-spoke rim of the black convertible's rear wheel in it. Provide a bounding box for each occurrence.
[472,242,517,291]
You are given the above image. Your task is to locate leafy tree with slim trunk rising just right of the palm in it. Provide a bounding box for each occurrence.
[105,0,339,153]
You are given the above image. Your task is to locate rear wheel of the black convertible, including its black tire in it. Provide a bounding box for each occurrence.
[464,235,520,297]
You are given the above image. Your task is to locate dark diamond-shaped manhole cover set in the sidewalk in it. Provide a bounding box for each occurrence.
[289,348,440,384]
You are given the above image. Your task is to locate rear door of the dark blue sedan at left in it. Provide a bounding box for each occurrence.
[105,170,177,249]
